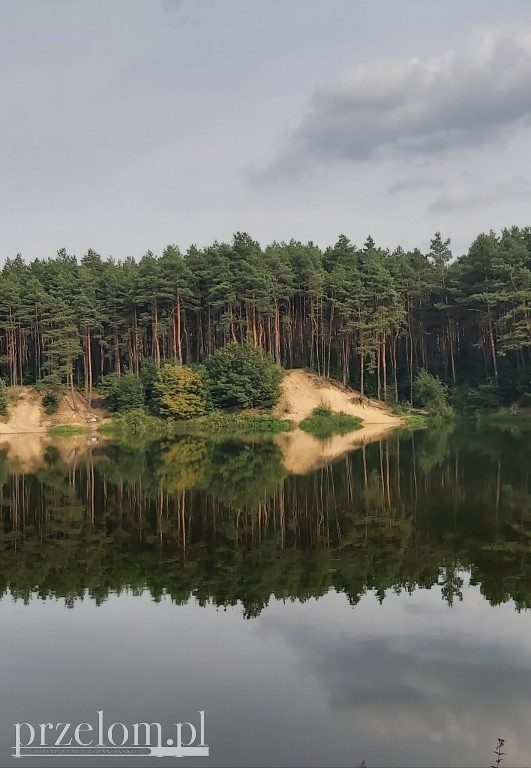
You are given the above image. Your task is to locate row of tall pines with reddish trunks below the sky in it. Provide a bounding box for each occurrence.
[0,227,531,402]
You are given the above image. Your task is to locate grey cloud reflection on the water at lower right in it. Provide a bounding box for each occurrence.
[262,591,531,765]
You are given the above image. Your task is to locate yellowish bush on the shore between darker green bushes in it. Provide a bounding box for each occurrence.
[153,364,205,420]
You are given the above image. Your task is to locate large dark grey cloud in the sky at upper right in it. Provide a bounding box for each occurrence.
[253,26,531,182]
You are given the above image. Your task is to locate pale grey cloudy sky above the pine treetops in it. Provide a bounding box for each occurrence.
[0,0,531,261]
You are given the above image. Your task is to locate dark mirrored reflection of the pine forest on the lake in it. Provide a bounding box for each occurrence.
[0,428,531,618]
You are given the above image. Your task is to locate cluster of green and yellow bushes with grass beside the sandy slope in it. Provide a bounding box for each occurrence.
[98,343,290,437]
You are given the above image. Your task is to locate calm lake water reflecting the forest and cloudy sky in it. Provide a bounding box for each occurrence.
[0,430,531,768]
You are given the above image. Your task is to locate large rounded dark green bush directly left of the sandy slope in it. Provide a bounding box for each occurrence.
[205,343,283,408]
